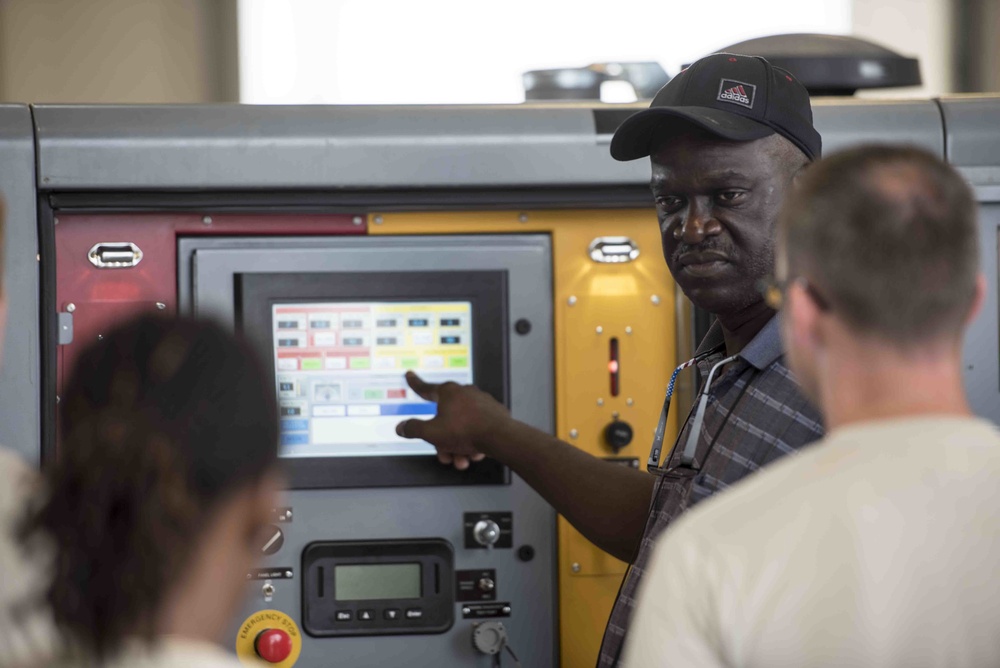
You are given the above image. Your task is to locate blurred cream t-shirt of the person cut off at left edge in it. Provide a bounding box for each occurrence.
[0,448,56,668]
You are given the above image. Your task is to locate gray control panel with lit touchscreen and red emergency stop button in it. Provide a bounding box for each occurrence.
[178,234,558,668]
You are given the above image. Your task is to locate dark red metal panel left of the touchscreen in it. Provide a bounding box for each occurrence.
[55,213,367,400]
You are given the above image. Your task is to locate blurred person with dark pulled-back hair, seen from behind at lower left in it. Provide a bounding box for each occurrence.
[24,316,281,668]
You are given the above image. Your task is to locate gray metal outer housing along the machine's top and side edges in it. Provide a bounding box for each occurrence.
[0,96,1000,463]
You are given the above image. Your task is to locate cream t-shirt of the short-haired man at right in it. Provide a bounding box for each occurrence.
[624,416,1000,668]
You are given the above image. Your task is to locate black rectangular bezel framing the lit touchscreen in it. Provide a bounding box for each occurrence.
[240,271,510,489]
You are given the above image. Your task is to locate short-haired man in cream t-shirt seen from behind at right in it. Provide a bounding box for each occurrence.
[624,146,1000,668]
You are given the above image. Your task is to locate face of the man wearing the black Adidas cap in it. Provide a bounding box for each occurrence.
[650,133,798,317]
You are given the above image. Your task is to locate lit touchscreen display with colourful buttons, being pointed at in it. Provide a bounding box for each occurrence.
[271,301,473,457]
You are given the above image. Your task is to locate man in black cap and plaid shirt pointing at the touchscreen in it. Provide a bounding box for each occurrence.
[397,54,823,666]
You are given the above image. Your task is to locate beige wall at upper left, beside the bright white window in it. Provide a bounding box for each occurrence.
[0,0,239,103]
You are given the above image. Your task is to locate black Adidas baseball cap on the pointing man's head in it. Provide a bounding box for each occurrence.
[611,53,823,160]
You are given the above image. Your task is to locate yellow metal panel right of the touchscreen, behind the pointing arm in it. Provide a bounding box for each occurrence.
[368,209,677,668]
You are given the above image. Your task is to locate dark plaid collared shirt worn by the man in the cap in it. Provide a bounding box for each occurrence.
[597,317,823,668]
